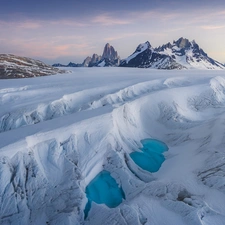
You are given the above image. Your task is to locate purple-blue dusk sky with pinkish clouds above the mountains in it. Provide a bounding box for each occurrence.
[0,0,225,64]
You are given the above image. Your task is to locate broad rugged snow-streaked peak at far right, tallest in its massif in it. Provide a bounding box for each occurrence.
[155,37,225,69]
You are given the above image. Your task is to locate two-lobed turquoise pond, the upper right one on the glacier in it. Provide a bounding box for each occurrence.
[130,139,168,173]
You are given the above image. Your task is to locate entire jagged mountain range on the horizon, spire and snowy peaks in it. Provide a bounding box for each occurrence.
[53,37,225,69]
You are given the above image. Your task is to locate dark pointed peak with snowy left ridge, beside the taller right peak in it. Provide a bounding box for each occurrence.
[120,41,183,69]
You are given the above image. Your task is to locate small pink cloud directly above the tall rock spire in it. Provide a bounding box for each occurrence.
[91,14,131,26]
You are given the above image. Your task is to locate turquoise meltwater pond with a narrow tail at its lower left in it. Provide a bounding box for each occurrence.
[84,170,125,218]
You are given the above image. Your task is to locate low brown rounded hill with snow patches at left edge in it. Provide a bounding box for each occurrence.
[0,54,65,79]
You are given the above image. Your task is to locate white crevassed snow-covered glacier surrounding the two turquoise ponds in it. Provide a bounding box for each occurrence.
[0,68,225,225]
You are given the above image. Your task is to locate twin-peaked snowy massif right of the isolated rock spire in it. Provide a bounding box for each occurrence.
[120,38,225,69]
